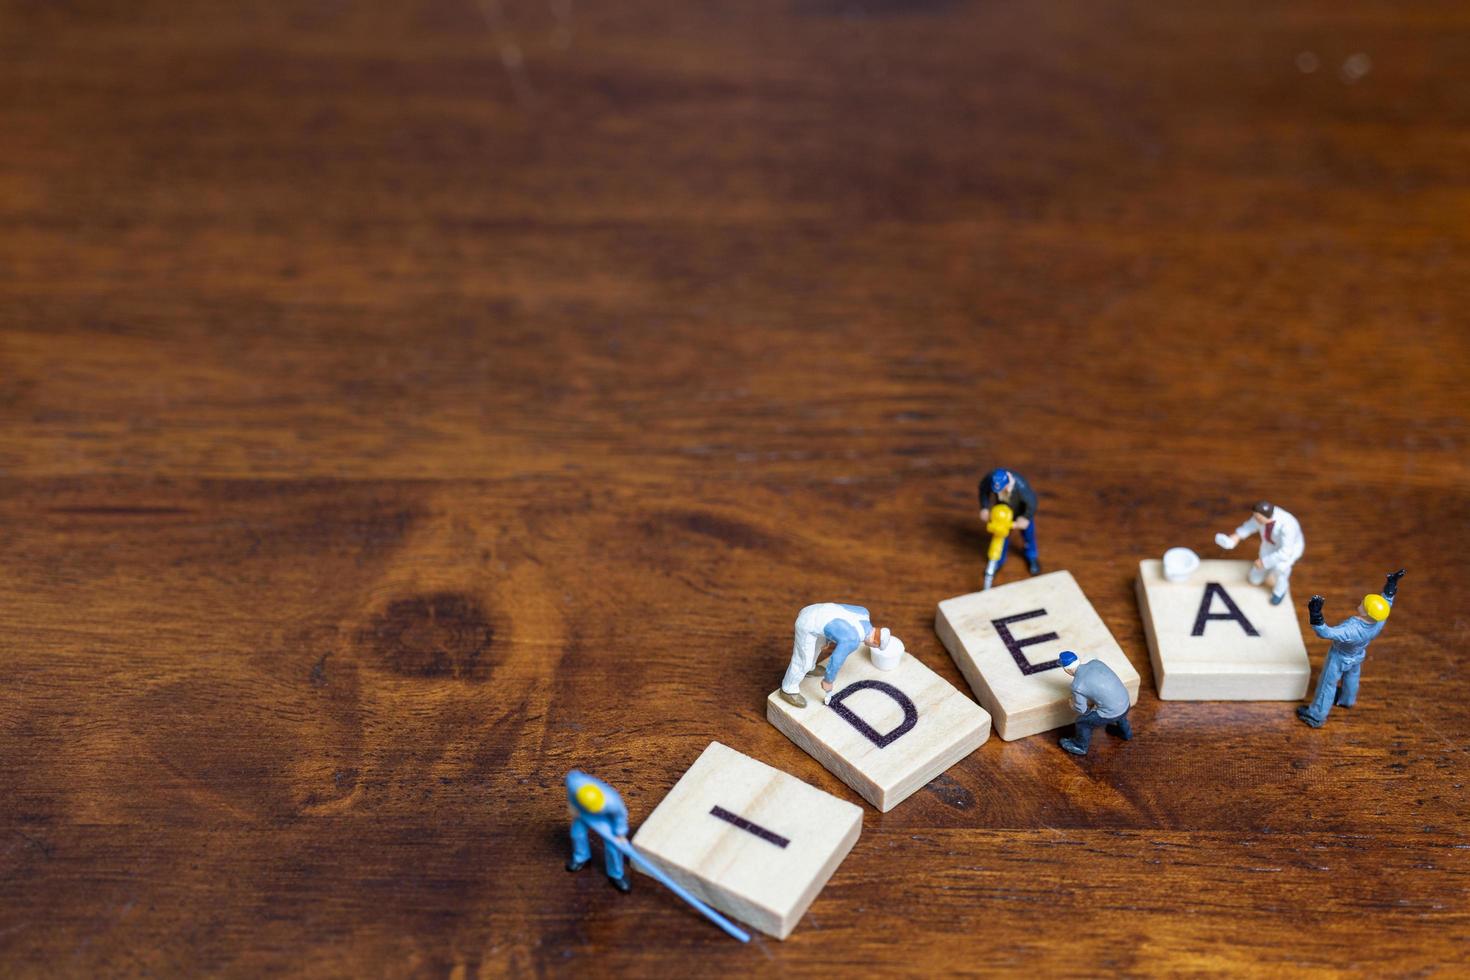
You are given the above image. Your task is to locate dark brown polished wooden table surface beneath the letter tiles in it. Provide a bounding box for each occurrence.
[0,0,1470,977]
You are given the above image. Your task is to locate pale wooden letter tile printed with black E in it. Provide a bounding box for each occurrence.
[933,572,1138,742]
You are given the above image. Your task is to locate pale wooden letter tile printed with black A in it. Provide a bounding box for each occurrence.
[1138,558,1311,701]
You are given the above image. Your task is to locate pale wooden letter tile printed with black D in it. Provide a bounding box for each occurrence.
[766,646,991,813]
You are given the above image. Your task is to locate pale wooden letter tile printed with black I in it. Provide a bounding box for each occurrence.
[632,742,863,939]
